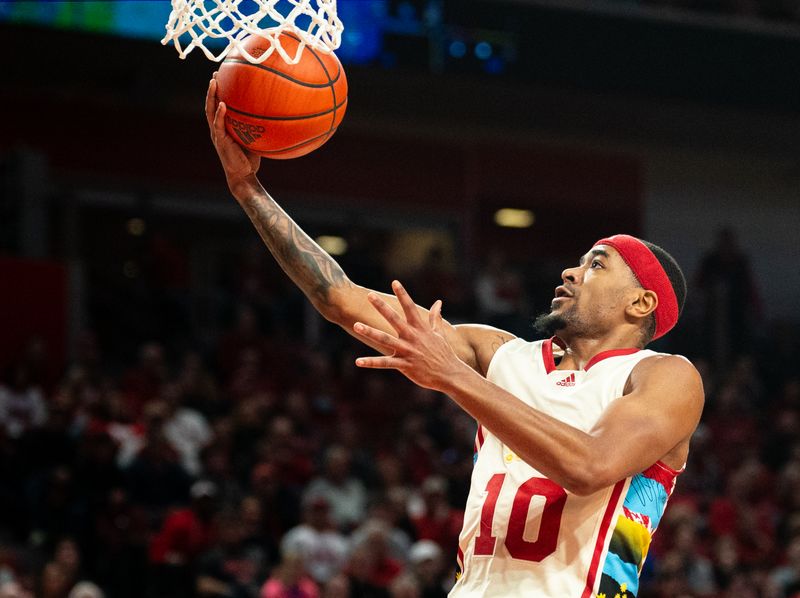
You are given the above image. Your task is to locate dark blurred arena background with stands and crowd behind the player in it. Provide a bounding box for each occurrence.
[0,0,800,598]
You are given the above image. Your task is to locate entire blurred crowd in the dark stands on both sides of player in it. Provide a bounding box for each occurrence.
[0,230,800,598]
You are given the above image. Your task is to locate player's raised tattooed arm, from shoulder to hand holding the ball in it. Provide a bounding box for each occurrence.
[205,79,512,371]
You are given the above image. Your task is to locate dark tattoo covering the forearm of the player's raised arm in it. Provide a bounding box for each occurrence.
[241,191,354,306]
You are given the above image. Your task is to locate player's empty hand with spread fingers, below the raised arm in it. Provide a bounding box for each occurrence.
[353,280,469,391]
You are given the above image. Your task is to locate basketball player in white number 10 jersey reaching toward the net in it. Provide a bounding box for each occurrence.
[206,80,704,598]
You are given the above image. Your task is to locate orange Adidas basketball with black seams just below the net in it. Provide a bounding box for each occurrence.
[217,31,347,159]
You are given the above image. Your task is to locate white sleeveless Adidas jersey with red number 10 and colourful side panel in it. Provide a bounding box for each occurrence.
[450,339,679,598]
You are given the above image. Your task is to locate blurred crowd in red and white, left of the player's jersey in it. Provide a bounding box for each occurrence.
[0,328,475,598]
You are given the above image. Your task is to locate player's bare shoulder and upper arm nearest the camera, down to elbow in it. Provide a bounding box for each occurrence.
[584,356,705,492]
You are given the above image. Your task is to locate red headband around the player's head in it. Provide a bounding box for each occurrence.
[595,235,679,340]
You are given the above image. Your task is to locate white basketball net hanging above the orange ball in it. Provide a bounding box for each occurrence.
[161,0,344,64]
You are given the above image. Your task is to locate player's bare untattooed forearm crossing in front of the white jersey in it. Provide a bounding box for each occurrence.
[442,368,604,494]
